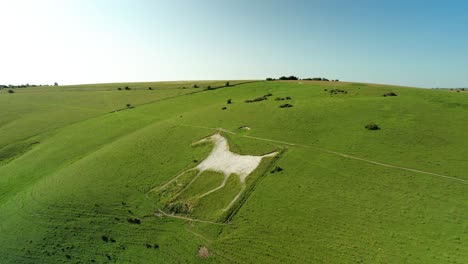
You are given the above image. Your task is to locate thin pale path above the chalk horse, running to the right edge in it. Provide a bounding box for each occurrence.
[172,124,468,184]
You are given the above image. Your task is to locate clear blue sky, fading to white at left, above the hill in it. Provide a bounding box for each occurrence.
[0,0,468,87]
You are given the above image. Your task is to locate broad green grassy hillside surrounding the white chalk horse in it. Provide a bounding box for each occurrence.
[0,81,468,264]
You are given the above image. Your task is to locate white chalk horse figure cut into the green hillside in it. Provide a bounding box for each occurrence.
[155,133,278,211]
